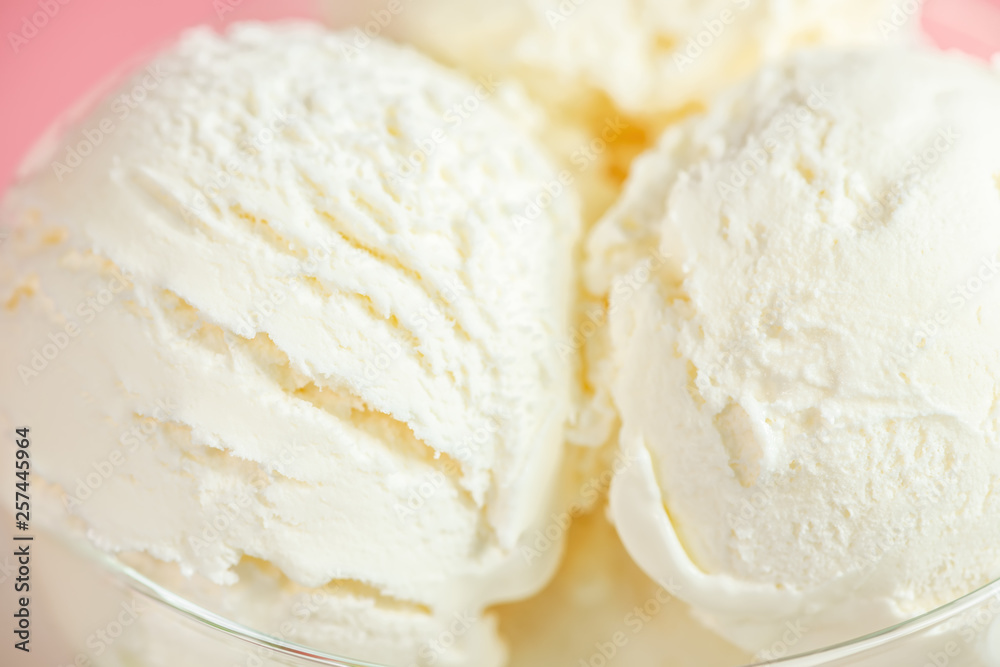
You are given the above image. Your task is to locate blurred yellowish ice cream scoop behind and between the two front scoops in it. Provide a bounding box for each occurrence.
[382,0,919,496]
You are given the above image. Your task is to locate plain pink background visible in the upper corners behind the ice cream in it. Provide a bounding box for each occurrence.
[0,0,1000,191]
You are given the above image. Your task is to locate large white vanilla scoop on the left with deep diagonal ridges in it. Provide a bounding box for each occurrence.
[0,24,578,665]
